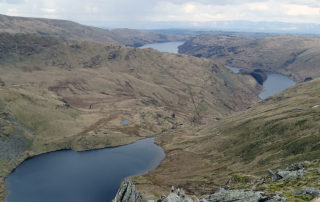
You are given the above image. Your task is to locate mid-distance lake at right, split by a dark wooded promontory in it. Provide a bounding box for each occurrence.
[226,66,296,99]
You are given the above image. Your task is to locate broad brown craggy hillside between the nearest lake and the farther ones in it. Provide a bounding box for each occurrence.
[0,33,259,200]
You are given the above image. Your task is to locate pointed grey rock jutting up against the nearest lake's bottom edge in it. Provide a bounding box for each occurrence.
[113,180,145,202]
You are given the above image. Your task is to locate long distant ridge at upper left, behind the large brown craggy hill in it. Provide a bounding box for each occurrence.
[0,15,187,46]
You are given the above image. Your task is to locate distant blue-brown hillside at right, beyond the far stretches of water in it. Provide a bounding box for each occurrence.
[179,35,320,81]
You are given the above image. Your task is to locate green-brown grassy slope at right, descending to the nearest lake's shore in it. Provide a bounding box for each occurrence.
[136,79,320,199]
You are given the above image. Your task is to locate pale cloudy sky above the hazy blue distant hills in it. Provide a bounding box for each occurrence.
[0,0,320,28]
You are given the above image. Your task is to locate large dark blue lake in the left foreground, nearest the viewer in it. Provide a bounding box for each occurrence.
[6,138,165,202]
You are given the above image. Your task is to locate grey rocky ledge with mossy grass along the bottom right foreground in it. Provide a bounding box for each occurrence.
[114,160,320,202]
